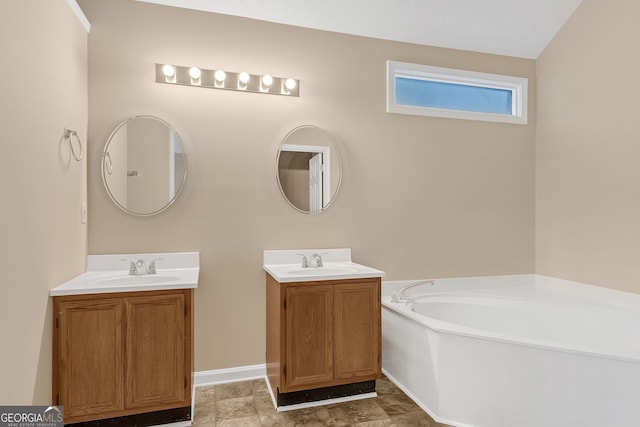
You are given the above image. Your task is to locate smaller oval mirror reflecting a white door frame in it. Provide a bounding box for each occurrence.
[277,125,342,214]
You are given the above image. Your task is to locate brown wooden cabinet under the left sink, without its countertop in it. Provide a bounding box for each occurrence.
[53,289,193,424]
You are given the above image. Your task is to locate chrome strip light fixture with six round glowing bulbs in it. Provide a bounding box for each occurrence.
[156,64,300,97]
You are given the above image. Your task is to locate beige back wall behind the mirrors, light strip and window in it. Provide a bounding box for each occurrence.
[81,0,536,371]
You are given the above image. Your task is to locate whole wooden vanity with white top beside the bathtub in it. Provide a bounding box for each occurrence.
[264,249,384,410]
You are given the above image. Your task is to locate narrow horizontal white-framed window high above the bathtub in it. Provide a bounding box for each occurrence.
[387,61,528,124]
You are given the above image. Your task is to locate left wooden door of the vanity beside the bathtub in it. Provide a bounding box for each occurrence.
[281,285,333,392]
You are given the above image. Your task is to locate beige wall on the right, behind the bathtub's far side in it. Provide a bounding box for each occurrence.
[536,0,640,292]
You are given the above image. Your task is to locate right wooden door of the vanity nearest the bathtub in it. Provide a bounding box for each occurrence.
[334,281,381,383]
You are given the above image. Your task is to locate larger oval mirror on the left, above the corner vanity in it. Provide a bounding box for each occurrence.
[102,116,187,216]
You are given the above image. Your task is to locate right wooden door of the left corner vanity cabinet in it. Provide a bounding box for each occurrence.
[125,293,190,410]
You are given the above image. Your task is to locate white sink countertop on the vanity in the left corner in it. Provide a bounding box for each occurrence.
[49,252,200,296]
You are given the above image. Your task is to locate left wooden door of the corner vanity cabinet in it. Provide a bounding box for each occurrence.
[54,298,124,422]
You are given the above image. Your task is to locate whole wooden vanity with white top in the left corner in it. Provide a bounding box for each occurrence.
[50,253,198,425]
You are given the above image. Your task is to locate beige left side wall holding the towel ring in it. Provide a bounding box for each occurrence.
[0,0,88,405]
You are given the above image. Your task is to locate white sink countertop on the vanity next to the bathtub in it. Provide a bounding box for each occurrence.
[263,248,384,283]
